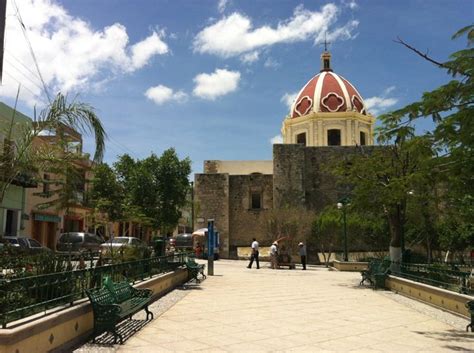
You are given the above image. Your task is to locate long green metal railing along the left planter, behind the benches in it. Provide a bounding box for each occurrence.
[0,253,188,328]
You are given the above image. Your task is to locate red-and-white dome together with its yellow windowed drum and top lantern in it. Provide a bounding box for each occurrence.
[281,51,375,146]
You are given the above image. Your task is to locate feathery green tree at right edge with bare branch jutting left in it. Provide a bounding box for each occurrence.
[379,25,474,256]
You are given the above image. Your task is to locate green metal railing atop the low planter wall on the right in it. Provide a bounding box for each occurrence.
[391,263,474,294]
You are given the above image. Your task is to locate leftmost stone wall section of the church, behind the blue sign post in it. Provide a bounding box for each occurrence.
[194,173,229,258]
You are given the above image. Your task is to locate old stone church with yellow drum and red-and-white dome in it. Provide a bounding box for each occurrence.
[194,51,375,258]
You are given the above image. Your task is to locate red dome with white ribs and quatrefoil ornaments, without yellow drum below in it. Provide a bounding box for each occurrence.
[290,69,367,118]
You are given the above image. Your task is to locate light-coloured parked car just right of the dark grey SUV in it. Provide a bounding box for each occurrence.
[100,237,151,260]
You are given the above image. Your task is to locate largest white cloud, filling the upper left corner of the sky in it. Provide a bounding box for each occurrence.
[0,0,169,104]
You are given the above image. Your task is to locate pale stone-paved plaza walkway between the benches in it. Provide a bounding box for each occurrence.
[79,260,474,352]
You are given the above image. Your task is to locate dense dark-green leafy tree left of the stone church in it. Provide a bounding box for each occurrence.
[97,148,191,233]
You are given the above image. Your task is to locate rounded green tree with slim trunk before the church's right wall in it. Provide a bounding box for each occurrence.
[336,135,433,261]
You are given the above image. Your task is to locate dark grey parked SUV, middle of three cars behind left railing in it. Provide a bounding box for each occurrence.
[56,232,104,255]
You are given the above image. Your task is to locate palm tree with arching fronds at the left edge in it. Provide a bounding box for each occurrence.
[0,93,106,204]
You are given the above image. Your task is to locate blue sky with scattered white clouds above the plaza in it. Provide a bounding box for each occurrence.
[0,0,474,172]
